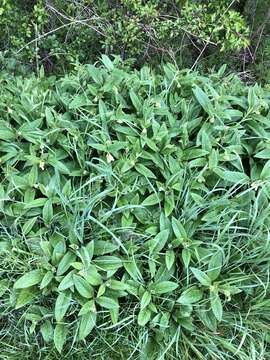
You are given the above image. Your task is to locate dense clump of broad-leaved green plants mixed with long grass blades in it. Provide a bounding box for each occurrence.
[0,56,270,359]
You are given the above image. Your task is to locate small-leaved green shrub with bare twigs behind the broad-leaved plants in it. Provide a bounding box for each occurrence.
[0,0,249,71]
